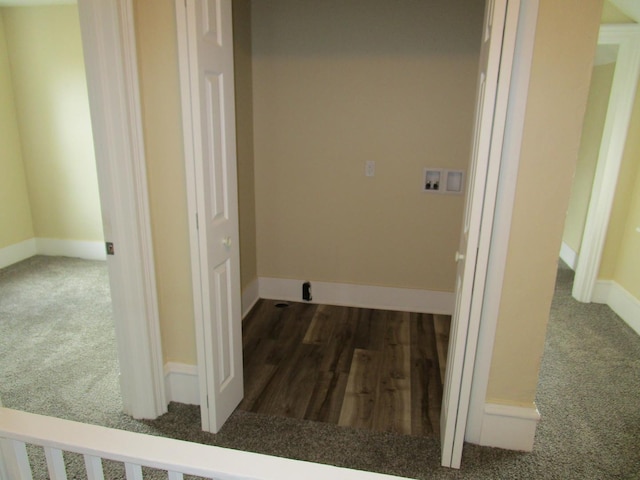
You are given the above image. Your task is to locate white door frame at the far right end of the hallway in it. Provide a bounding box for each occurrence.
[572,24,640,302]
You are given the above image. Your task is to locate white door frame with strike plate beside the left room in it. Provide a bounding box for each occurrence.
[78,0,167,418]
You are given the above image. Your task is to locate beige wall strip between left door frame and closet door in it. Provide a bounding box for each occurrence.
[134,0,196,365]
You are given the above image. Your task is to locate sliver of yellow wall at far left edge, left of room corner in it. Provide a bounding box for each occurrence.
[0,9,33,248]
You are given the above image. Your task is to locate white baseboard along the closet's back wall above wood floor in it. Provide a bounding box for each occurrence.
[258,277,455,315]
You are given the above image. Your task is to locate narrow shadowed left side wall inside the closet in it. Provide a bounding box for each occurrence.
[233,0,258,290]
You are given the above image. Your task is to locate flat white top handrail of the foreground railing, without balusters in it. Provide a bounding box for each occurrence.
[0,407,412,480]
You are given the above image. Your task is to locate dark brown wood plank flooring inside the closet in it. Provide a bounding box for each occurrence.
[239,300,451,435]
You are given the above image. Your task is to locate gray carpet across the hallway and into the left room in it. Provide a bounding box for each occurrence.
[0,257,640,479]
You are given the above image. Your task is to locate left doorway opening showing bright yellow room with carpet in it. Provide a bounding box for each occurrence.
[0,5,122,420]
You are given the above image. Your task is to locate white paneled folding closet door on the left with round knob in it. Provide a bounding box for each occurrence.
[177,0,244,432]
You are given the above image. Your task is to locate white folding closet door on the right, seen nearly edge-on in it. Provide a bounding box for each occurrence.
[440,0,507,468]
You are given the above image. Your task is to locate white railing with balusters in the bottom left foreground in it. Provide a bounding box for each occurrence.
[0,407,410,480]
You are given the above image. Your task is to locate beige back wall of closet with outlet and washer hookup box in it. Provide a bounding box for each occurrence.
[252,0,483,291]
